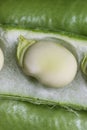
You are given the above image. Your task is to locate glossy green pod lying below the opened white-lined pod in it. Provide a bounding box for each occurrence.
[0,100,87,130]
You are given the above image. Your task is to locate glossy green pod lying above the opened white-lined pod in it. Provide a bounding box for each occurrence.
[0,0,87,36]
